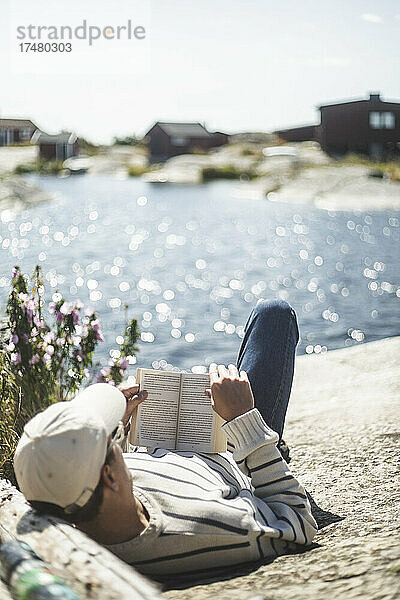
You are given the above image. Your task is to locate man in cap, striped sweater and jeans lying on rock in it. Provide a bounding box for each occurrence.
[14,301,317,579]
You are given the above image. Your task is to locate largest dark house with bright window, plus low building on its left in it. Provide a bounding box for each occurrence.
[274,94,400,159]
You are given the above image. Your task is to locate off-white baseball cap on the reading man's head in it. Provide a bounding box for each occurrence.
[14,383,126,512]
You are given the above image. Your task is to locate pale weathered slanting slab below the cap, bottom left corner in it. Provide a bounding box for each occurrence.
[0,480,160,600]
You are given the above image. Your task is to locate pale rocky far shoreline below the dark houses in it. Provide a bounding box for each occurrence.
[0,144,400,212]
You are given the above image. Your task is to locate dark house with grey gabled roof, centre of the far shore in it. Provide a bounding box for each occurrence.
[145,121,229,161]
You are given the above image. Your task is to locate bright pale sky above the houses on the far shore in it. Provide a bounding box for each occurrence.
[0,0,400,143]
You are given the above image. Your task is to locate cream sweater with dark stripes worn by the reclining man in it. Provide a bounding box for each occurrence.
[107,409,317,579]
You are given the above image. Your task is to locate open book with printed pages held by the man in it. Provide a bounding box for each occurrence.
[129,369,226,453]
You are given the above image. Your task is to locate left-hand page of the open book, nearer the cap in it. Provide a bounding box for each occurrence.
[130,369,180,450]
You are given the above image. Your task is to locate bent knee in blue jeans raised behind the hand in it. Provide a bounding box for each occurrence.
[237,300,299,440]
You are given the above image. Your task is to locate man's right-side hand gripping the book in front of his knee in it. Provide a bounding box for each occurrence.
[206,363,254,421]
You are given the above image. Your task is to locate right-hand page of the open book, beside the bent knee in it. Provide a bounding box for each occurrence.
[177,373,226,452]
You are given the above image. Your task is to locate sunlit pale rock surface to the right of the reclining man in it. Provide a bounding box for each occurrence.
[165,337,400,600]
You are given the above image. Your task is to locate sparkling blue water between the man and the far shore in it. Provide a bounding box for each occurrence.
[0,176,400,369]
